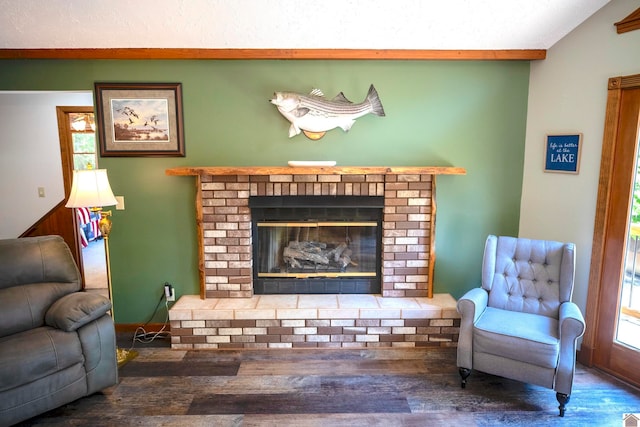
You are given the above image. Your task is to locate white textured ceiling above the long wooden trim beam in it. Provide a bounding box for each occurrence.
[0,0,608,50]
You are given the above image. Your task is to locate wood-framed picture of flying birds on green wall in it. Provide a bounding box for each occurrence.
[95,82,185,157]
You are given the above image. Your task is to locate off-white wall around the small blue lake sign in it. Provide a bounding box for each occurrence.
[520,0,640,313]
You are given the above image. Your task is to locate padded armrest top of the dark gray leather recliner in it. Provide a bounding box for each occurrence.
[45,292,111,332]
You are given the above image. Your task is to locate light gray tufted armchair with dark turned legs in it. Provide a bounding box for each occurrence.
[457,236,585,417]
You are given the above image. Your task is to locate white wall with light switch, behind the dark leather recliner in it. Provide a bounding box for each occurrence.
[0,92,93,239]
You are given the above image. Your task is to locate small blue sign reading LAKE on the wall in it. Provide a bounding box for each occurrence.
[544,133,582,174]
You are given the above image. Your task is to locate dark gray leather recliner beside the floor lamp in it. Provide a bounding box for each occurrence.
[0,236,118,426]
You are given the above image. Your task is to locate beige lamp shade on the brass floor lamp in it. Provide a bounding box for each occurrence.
[65,169,118,208]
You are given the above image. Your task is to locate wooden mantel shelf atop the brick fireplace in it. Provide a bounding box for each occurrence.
[166,166,467,176]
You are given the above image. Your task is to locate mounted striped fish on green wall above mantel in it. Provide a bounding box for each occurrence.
[270,85,384,139]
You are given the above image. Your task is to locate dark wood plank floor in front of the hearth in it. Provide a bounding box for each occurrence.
[15,339,640,427]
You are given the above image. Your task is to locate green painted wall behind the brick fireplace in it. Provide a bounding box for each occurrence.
[0,60,529,323]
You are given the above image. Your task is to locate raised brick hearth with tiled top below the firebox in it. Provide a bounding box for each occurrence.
[169,294,460,350]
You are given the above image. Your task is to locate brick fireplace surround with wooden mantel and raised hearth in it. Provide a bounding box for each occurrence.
[167,167,465,348]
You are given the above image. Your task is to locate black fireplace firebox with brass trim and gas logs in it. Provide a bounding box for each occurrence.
[249,196,384,294]
